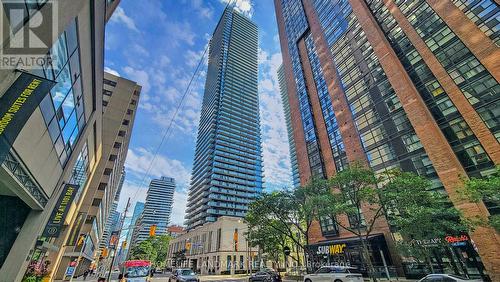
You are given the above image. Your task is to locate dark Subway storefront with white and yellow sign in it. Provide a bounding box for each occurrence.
[307,234,396,276]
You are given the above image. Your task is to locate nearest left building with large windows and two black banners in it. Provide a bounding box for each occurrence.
[0,0,123,281]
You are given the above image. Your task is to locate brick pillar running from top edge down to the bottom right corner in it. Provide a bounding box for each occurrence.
[349,0,500,280]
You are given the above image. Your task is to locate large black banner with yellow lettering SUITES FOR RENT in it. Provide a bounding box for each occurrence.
[0,72,55,164]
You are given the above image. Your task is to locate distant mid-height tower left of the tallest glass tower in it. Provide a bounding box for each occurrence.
[132,176,175,246]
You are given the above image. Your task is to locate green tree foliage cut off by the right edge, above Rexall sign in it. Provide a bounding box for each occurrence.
[464,166,500,232]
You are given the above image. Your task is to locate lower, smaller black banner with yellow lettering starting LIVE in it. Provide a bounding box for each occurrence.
[42,184,80,237]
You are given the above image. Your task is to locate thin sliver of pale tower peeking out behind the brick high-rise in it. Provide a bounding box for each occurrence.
[278,64,300,187]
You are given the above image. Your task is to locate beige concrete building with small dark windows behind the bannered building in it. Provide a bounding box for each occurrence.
[52,73,141,279]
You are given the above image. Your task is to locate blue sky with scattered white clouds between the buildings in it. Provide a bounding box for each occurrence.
[105,0,291,224]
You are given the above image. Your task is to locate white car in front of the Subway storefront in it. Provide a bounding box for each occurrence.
[304,266,363,282]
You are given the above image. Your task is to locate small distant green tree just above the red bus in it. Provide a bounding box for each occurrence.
[130,235,170,267]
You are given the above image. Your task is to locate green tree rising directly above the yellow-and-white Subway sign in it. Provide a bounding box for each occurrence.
[305,165,384,279]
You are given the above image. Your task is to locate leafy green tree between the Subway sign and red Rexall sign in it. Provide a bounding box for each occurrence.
[379,170,471,272]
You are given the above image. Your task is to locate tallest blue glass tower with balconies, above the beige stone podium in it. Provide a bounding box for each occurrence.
[185,8,262,229]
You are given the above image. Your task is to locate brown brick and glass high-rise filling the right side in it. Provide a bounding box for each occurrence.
[274,0,500,280]
